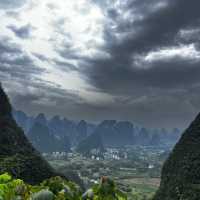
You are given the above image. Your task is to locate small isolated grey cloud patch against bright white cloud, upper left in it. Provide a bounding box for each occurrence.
[8,24,33,39]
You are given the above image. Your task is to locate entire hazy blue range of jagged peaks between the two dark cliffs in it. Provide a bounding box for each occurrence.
[13,111,181,153]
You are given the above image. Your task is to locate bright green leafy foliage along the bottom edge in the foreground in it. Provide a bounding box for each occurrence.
[0,173,127,200]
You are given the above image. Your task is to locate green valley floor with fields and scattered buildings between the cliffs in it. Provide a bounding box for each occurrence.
[47,146,169,199]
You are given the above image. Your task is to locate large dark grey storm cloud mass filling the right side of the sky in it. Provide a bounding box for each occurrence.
[74,0,200,126]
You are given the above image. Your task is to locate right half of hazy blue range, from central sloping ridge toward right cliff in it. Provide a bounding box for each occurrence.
[77,120,181,153]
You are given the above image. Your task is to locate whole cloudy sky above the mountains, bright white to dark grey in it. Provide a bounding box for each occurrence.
[0,0,200,128]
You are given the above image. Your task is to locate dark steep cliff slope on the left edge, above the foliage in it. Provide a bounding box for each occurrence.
[0,86,56,184]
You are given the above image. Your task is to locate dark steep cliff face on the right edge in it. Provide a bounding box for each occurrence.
[154,114,200,200]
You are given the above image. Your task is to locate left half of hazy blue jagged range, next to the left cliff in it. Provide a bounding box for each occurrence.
[13,110,96,153]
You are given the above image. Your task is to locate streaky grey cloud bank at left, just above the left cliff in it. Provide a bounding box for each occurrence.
[0,38,89,123]
